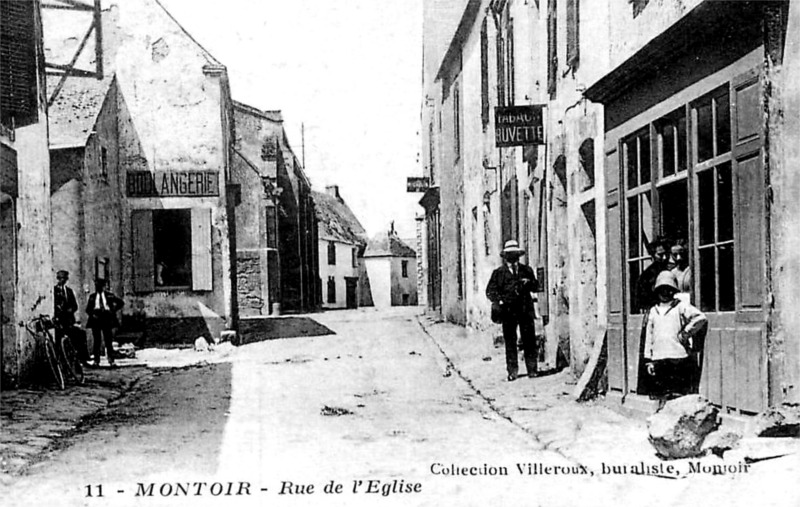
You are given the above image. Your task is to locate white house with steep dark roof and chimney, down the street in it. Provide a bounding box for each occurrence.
[313,185,372,308]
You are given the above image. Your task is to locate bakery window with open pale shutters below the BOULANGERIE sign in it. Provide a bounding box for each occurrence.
[131,208,213,292]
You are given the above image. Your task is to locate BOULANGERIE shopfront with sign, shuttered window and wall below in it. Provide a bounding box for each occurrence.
[126,170,230,342]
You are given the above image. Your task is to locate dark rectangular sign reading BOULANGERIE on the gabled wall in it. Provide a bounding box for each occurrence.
[125,171,219,197]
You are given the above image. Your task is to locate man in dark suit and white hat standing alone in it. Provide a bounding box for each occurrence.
[486,239,539,382]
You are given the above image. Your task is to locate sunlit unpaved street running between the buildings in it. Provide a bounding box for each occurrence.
[0,309,800,506]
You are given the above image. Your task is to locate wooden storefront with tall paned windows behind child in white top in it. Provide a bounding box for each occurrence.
[586,2,772,414]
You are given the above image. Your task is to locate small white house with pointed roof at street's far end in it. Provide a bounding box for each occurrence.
[364,224,417,308]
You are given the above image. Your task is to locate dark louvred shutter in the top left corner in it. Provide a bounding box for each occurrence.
[0,0,38,128]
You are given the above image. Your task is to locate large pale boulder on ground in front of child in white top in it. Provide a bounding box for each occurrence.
[647,394,720,459]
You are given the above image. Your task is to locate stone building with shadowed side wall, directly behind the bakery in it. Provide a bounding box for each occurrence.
[232,102,318,317]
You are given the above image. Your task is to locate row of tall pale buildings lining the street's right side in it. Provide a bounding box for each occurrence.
[421,0,800,414]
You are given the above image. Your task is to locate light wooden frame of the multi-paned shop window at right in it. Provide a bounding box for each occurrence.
[617,79,740,315]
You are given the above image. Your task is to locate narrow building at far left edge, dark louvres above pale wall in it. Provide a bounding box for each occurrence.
[0,0,54,389]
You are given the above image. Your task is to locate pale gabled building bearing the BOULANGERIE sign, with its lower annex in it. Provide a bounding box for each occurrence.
[45,0,237,342]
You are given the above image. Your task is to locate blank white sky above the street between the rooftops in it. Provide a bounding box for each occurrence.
[160,0,422,238]
